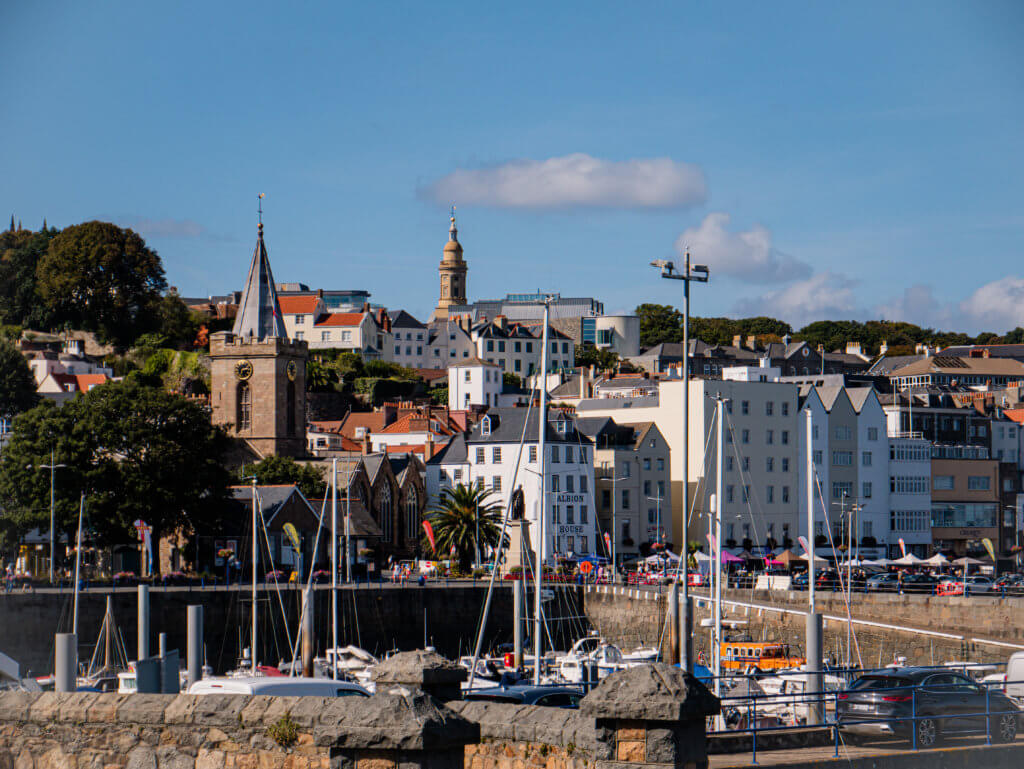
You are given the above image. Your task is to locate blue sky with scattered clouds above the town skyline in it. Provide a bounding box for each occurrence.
[0,0,1024,332]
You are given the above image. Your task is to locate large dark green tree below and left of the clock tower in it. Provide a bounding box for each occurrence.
[0,376,230,573]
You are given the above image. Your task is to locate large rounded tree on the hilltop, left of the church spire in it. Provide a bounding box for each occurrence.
[36,221,167,347]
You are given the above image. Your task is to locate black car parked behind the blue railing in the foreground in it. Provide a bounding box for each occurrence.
[836,668,1021,747]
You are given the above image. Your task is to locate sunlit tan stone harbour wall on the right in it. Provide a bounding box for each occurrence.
[584,587,1024,668]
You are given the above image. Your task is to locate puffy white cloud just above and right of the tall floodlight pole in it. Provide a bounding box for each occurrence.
[676,212,811,283]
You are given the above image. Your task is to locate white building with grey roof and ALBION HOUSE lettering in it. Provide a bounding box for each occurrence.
[427,408,604,558]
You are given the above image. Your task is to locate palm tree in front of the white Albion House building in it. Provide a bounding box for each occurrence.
[427,483,502,571]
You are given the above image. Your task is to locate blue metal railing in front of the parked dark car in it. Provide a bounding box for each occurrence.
[702,664,1024,764]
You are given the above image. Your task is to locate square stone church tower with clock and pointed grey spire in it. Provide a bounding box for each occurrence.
[210,217,309,457]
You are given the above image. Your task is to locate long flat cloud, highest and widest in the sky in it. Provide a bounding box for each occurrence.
[419,153,708,209]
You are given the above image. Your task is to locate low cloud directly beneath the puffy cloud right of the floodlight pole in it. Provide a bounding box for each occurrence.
[733,272,863,329]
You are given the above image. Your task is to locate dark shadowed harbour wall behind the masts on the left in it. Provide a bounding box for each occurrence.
[0,582,586,675]
